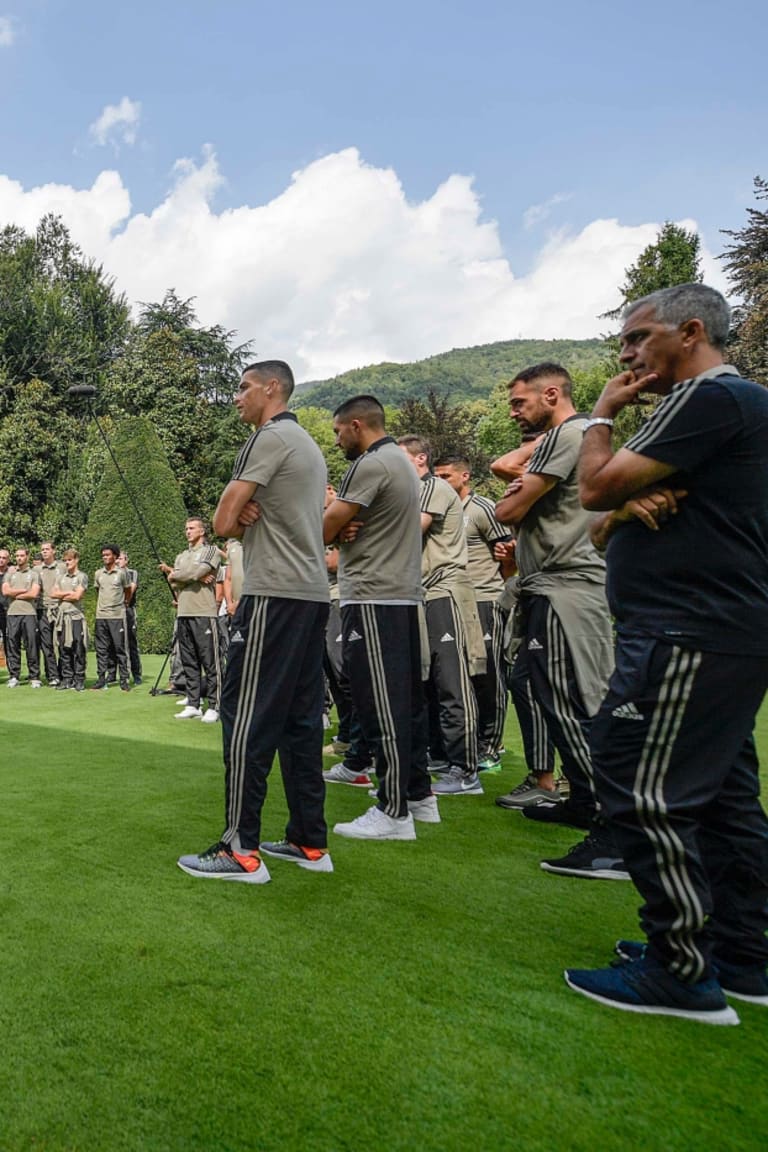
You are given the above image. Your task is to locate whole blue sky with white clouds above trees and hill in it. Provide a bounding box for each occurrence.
[0,0,768,376]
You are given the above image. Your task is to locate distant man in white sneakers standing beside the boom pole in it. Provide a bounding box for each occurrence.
[160,516,221,723]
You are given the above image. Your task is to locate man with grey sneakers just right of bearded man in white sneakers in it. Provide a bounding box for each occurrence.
[397,435,485,796]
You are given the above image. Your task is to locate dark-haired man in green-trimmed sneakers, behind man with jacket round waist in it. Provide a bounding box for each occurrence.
[434,455,511,772]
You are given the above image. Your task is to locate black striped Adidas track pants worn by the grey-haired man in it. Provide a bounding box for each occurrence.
[592,636,768,982]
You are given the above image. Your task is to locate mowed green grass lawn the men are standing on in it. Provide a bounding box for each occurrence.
[0,658,768,1152]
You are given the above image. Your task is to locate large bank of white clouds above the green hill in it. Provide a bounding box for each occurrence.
[0,149,724,379]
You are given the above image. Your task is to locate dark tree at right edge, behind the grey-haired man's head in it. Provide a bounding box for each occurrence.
[720,176,768,384]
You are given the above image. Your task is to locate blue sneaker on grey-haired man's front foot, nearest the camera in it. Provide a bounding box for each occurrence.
[564,956,739,1024]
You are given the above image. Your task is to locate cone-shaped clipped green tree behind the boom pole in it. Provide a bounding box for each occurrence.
[79,417,187,652]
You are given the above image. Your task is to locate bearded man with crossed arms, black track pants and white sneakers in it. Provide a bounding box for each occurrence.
[324,396,440,840]
